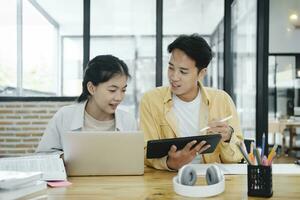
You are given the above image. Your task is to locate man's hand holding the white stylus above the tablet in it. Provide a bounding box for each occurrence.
[207,121,232,142]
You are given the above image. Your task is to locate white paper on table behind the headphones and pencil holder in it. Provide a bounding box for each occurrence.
[191,163,300,175]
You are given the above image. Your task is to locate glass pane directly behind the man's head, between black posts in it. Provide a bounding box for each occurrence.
[163,0,224,86]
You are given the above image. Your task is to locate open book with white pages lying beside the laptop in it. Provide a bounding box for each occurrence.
[0,154,67,180]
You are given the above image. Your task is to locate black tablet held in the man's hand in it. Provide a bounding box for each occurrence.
[146,134,222,159]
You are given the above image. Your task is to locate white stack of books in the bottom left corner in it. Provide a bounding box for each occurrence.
[0,171,47,200]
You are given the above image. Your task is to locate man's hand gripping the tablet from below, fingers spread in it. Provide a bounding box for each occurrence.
[167,140,210,170]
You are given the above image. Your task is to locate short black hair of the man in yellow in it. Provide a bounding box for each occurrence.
[168,33,212,71]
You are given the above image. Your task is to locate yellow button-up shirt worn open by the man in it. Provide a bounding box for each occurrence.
[140,82,243,169]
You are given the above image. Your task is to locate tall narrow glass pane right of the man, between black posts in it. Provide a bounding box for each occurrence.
[231,0,257,139]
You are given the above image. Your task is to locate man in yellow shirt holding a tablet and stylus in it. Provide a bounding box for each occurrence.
[140,34,243,170]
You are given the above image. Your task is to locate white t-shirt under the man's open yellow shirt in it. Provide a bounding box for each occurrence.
[172,91,201,137]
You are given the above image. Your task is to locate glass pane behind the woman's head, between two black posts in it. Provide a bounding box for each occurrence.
[90,0,156,116]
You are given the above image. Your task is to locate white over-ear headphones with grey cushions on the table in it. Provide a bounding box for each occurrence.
[173,165,225,197]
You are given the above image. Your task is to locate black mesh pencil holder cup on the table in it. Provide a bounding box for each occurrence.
[247,165,273,197]
